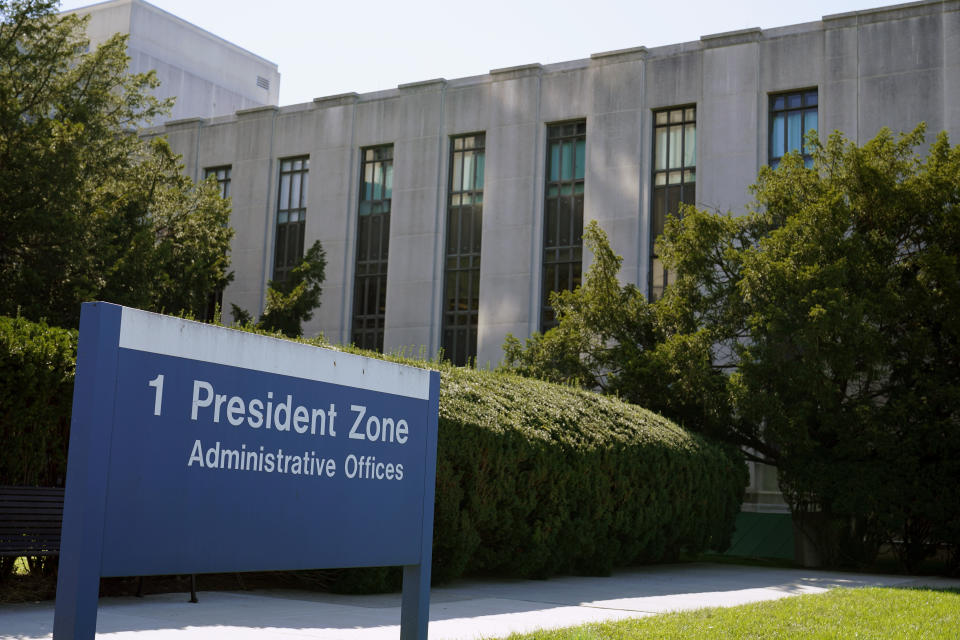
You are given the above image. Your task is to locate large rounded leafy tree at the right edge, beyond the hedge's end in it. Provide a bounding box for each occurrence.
[700,126,960,570]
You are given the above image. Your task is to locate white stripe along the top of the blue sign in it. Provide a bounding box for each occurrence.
[119,307,430,400]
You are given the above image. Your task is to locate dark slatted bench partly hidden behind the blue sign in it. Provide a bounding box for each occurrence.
[0,486,198,602]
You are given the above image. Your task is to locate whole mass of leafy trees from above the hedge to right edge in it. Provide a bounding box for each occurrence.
[505,125,960,570]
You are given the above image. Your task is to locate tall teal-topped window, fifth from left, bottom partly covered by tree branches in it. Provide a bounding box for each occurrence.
[540,120,587,331]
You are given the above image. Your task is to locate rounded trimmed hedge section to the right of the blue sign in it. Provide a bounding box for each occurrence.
[434,367,747,579]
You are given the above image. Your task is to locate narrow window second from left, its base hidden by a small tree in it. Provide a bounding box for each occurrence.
[273,156,310,282]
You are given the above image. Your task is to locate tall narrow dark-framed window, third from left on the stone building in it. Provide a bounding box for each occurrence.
[352,145,393,351]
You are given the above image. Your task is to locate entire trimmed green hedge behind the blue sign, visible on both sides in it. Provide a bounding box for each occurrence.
[0,318,747,591]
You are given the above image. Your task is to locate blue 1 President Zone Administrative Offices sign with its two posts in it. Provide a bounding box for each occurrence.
[54,303,439,638]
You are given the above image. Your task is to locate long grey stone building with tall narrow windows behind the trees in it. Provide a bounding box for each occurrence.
[134,0,960,510]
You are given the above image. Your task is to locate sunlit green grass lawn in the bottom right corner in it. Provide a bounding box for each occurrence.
[509,588,960,640]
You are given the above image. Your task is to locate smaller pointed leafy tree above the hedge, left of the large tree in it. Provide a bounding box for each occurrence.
[503,221,730,435]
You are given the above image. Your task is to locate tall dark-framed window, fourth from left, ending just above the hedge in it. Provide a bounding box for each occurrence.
[443,133,485,366]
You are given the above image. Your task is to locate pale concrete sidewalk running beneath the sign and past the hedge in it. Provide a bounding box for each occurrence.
[0,564,960,640]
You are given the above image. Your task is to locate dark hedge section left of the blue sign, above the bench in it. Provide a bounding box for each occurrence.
[0,317,77,486]
